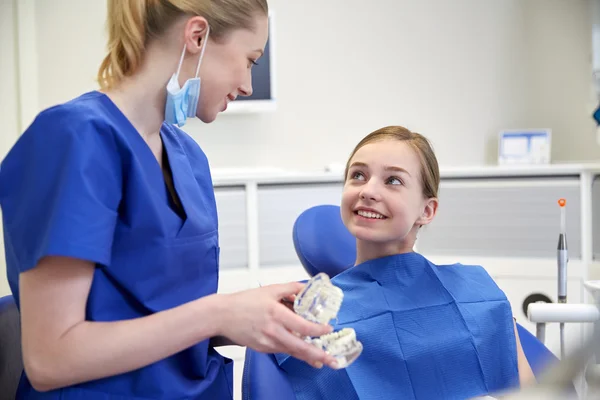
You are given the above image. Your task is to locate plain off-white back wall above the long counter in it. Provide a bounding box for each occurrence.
[27,0,600,169]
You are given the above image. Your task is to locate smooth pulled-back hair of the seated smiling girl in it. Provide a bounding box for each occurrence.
[344,126,440,198]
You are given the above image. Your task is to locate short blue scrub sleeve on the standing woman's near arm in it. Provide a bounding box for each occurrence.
[0,109,122,272]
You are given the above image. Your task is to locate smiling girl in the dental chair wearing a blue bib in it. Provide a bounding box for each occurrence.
[277,126,534,400]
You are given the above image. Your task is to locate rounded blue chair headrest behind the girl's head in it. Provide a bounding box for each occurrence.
[293,205,356,277]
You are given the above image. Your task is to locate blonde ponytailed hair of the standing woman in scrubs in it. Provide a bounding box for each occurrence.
[98,0,269,89]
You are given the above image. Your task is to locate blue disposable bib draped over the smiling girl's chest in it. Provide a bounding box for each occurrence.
[276,253,519,400]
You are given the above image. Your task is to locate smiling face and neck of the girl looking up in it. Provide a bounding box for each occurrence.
[341,139,437,261]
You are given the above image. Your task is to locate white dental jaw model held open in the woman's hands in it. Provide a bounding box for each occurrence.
[294,273,363,369]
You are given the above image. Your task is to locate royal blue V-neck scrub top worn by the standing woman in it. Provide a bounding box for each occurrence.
[0,92,233,400]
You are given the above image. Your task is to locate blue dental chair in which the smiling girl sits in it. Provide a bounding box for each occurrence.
[242,205,558,400]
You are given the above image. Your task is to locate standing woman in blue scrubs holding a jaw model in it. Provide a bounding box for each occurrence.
[0,0,334,400]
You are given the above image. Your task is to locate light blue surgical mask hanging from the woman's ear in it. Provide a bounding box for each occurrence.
[165,29,210,128]
